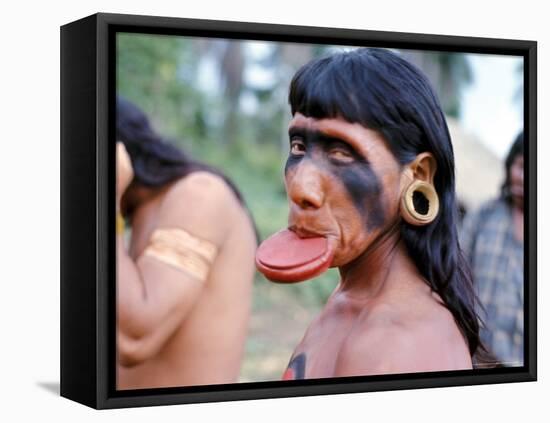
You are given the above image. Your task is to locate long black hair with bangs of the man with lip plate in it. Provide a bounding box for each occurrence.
[289,48,480,356]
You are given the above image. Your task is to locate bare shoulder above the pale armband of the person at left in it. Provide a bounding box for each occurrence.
[158,171,242,245]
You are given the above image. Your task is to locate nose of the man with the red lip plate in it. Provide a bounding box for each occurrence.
[287,160,325,210]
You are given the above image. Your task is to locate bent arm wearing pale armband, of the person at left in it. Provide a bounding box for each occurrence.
[117,175,236,366]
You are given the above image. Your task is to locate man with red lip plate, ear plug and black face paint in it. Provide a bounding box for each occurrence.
[256,49,480,380]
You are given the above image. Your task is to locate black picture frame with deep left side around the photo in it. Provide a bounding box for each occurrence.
[61,13,537,409]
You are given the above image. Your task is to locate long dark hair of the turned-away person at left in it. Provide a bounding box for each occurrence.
[116,96,243,212]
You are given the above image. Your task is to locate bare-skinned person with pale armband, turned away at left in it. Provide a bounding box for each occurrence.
[116,98,256,389]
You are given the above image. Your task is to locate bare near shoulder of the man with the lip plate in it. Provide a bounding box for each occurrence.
[336,303,471,376]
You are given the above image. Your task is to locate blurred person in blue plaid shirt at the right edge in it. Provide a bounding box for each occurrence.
[461,132,524,367]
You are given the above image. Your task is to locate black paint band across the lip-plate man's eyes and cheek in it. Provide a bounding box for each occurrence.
[285,128,385,231]
